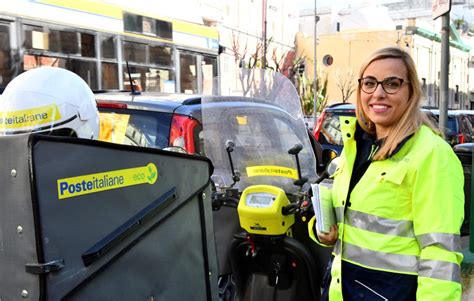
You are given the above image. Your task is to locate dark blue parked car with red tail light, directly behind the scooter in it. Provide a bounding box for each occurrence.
[95,92,324,173]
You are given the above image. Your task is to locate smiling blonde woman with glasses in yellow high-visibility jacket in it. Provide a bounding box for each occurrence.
[309,47,464,301]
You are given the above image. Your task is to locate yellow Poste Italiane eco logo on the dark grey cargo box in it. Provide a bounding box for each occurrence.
[57,163,158,199]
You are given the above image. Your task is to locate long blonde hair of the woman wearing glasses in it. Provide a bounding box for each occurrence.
[356,47,439,160]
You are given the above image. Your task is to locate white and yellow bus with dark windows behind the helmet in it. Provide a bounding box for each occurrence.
[0,0,219,94]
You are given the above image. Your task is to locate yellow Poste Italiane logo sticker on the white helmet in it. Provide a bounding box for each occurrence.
[0,105,61,129]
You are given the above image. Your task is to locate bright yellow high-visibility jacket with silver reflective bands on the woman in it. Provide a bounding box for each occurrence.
[308,117,464,301]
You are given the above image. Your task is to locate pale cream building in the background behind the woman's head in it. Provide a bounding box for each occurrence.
[298,1,474,109]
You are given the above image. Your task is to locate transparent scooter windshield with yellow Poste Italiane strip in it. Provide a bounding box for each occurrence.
[202,69,317,193]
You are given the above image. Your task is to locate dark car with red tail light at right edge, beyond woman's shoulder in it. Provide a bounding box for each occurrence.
[431,110,474,146]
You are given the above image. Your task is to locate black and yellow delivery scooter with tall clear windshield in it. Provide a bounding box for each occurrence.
[202,70,329,301]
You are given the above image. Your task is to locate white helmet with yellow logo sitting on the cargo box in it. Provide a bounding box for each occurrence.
[0,67,99,139]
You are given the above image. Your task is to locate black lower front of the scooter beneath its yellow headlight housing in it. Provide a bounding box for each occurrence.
[230,233,321,300]
